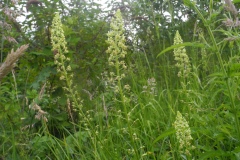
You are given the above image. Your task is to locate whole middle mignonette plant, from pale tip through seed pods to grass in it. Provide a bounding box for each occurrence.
[103,9,142,159]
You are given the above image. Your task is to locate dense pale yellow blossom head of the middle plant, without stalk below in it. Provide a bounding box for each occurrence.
[106,10,129,93]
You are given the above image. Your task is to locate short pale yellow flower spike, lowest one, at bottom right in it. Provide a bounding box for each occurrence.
[173,111,195,156]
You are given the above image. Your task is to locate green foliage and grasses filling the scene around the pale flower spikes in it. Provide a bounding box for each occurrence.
[0,0,240,160]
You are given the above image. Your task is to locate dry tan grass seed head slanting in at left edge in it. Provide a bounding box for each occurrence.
[0,44,28,81]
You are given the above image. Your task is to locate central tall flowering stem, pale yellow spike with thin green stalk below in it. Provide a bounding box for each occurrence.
[106,9,140,159]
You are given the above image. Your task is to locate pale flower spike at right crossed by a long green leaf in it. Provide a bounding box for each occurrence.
[173,31,191,78]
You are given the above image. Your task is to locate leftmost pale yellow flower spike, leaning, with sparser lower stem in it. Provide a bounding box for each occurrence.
[51,13,82,110]
